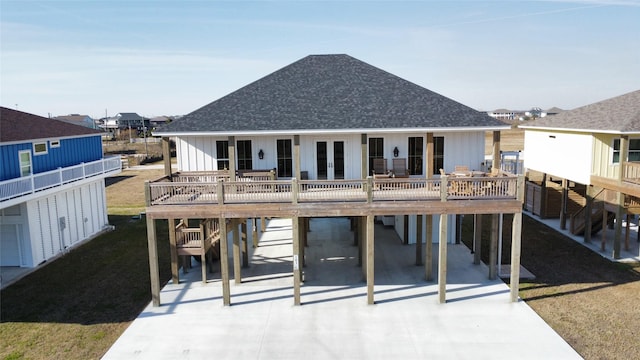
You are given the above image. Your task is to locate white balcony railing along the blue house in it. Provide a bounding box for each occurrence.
[0,156,122,208]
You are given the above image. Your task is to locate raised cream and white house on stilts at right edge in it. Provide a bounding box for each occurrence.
[519,90,640,258]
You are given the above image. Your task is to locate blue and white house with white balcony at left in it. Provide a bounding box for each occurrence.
[0,107,121,268]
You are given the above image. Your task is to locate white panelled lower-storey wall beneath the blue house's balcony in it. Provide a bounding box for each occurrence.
[22,179,108,267]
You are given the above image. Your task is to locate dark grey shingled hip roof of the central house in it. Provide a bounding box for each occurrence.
[156,55,505,135]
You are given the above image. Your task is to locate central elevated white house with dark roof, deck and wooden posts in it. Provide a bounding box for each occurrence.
[146,55,523,305]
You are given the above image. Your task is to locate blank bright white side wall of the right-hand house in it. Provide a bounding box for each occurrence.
[524,129,593,185]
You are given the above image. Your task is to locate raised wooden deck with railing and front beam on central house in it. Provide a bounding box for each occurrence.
[146,173,523,218]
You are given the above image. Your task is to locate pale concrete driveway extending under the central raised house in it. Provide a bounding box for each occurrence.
[104,218,580,359]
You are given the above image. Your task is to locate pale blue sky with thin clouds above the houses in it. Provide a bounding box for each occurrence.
[0,0,640,118]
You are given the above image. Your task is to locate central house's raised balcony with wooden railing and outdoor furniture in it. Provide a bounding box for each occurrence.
[146,171,524,218]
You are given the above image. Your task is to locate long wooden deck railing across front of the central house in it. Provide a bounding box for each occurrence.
[146,174,522,206]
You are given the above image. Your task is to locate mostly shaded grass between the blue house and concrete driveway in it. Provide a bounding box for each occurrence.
[0,216,170,359]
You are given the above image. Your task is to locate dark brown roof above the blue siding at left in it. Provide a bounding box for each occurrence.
[0,107,100,142]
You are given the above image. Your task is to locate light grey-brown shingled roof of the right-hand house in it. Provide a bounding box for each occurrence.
[520,90,640,133]
